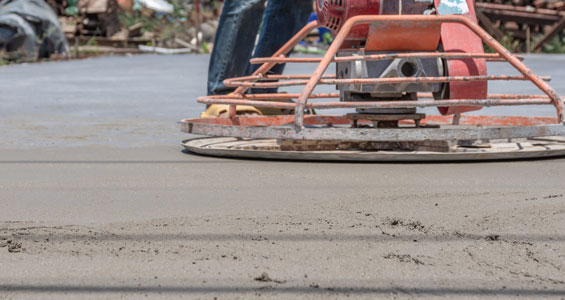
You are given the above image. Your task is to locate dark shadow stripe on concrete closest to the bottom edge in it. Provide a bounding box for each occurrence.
[0,284,565,297]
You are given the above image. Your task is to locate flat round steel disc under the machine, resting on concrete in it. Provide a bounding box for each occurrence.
[182,137,565,162]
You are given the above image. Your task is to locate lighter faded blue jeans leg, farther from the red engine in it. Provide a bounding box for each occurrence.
[208,0,265,95]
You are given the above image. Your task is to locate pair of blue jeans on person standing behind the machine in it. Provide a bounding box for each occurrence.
[208,0,312,95]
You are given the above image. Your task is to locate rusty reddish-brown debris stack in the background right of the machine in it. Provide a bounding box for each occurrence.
[475,0,565,53]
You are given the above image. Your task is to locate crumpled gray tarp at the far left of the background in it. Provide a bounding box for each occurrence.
[0,0,69,61]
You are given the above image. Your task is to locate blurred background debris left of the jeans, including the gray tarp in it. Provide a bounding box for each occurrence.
[0,0,221,63]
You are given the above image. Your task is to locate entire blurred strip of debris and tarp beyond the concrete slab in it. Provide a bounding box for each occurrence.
[0,0,565,62]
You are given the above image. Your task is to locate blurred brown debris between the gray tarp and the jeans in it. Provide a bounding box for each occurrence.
[55,0,221,54]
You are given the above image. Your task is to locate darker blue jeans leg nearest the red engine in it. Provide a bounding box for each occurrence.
[247,0,312,94]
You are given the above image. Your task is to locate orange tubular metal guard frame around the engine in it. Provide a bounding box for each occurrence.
[191,15,564,138]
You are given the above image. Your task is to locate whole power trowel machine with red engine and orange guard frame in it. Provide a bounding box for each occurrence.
[181,0,565,161]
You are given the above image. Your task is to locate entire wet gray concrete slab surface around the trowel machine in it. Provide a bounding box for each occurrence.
[0,55,565,299]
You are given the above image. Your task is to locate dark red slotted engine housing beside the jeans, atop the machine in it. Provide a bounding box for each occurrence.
[316,0,381,48]
